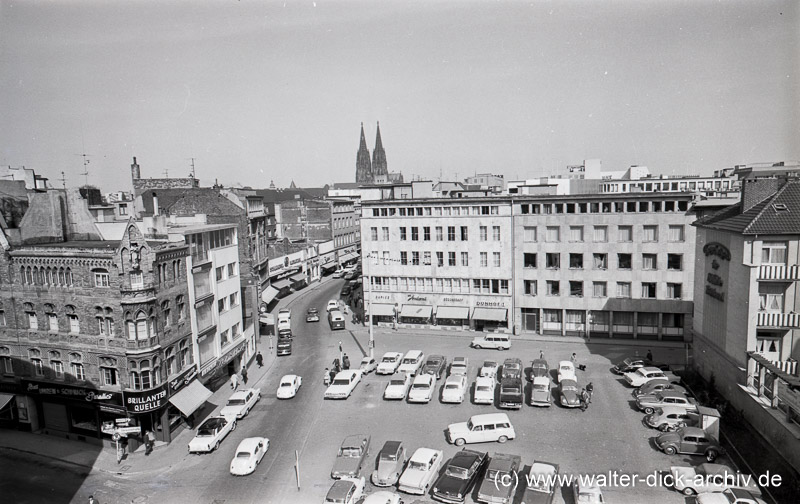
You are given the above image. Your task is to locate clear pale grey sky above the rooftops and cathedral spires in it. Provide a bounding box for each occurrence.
[0,0,800,191]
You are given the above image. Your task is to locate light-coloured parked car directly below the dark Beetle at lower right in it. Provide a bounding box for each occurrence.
[669,463,761,496]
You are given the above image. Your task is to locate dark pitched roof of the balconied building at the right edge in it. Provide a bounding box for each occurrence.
[696,181,800,235]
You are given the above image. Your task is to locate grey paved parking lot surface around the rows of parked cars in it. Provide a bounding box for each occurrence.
[294,333,704,503]
